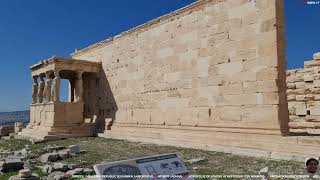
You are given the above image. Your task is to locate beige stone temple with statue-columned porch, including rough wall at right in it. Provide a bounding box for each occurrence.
[19,0,320,159]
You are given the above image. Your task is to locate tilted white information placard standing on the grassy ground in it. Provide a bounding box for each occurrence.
[93,153,193,180]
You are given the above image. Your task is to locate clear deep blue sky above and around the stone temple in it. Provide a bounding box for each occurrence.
[0,0,320,111]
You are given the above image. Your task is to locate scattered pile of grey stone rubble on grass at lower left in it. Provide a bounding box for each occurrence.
[0,145,94,180]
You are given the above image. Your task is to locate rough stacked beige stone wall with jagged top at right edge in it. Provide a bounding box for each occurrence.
[287,53,320,134]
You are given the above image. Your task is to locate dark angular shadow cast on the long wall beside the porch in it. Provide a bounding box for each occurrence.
[96,67,118,133]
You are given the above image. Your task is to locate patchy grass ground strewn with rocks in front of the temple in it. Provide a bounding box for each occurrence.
[0,137,304,180]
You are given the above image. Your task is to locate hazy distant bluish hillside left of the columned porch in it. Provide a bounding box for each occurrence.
[0,111,30,125]
